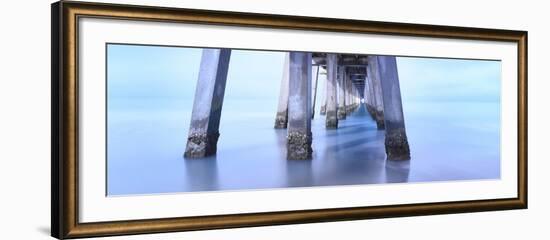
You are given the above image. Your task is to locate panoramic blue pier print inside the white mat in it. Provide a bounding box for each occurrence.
[105,43,501,196]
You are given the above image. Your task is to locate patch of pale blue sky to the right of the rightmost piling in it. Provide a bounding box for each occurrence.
[397,57,501,101]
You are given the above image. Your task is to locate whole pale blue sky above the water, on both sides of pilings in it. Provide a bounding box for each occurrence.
[107,44,501,102]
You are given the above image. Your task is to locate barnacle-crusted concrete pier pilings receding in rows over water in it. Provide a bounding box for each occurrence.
[184,49,410,160]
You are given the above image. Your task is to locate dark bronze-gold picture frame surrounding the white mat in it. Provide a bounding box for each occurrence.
[51,1,527,239]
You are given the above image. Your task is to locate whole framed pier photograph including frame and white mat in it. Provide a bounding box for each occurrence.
[51,1,527,239]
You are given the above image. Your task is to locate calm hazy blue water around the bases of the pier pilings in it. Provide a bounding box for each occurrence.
[107,99,500,195]
